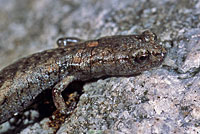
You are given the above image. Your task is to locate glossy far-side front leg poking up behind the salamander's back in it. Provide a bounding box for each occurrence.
[57,37,84,47]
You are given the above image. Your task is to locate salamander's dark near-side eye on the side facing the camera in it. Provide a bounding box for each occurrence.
[135,51,150,64]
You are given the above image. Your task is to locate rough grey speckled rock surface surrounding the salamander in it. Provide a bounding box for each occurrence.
[0,0,200,134]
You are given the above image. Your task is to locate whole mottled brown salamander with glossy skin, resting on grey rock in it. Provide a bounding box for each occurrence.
[0,31,166,124]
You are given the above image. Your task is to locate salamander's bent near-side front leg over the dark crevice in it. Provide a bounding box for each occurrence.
[52,76,75,114]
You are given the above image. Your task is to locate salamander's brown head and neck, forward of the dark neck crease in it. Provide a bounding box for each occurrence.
[86,31,167,78]
